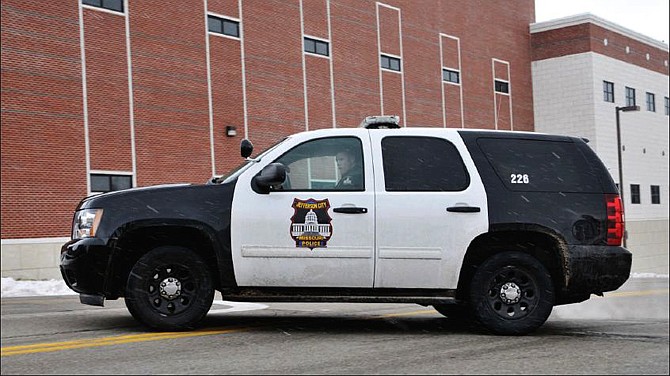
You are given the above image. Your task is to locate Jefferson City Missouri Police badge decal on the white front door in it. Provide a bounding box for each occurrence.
[291,198,333,249]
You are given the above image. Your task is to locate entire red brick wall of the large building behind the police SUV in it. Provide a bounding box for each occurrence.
[2,0,536,239]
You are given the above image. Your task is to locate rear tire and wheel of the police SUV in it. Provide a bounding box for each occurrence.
[469,252,554,335]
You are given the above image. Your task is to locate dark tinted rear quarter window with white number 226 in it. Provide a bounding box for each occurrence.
[477,138,602,193]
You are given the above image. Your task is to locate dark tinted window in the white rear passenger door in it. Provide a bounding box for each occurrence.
[382,136,470,192]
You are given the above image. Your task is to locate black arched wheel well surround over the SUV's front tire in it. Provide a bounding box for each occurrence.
[106,225,221,297]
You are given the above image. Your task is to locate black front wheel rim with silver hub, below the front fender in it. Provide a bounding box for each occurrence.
[145,264,198,316]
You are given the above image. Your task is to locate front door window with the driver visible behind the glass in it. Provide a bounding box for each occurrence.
[275,137,365,191]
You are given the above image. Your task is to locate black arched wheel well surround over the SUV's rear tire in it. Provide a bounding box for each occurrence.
[456,231,566,301]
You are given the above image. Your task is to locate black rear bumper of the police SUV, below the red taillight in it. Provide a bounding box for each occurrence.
[566,245,633,303]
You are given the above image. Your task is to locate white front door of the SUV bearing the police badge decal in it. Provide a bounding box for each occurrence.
[231,129,375,288]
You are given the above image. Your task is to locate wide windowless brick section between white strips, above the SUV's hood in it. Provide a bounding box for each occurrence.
[128,0,212,186]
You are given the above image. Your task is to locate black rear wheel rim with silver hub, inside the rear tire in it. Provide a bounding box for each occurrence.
[486,266,540,320]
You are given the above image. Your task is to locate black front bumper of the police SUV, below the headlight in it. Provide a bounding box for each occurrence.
[60,238,112,296]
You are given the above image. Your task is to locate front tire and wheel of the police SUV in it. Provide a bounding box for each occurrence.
[125,247,214,331]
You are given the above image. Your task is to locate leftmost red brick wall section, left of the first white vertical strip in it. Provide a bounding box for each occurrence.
[0,0,86,239]
